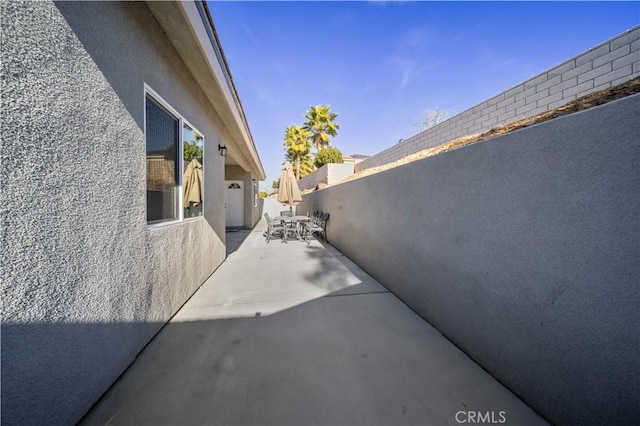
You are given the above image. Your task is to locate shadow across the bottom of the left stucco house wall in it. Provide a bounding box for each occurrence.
[0,322,163,425]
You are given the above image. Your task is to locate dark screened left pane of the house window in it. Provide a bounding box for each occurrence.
[145,96,180,222]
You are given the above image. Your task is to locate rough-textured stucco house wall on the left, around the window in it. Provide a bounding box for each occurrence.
[0,1,240,425]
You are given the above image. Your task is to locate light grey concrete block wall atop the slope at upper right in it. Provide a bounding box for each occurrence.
[355,26,640,172]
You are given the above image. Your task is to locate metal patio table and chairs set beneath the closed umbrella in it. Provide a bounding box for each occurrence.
[264,210,329,244]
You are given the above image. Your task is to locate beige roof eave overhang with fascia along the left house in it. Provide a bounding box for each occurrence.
[146,1,266,180]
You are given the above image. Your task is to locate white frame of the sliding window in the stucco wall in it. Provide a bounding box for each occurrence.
[142,83,206,230]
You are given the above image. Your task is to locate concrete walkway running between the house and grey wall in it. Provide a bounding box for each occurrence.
[82,200,546,425]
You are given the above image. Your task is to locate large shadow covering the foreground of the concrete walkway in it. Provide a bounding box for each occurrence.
[75,285,545,425]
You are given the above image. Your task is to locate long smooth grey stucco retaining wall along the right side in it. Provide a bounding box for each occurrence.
[298,94,640,425]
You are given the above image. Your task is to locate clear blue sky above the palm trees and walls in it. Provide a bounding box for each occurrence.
[208,1,640,188]
